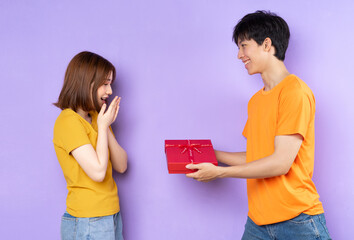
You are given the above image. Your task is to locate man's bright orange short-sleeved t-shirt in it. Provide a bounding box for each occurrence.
[243,75,323,225]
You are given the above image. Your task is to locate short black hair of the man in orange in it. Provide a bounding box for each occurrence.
[232,11,290,61]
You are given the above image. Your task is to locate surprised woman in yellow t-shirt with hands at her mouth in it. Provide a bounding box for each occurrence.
[53,52,127,240]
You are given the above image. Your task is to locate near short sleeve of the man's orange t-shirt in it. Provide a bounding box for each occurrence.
[276,88,312,138]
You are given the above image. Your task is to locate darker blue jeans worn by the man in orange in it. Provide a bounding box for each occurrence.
[242,213,331,240]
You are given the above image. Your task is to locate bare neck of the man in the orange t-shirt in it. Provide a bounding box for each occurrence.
[261,60,290,91]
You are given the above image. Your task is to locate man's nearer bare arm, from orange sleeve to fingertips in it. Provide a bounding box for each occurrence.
[187,134,303,182]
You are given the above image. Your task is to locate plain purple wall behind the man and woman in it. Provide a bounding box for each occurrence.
[0,0,354,240]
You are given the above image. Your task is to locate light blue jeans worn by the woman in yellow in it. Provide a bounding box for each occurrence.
[61,212,124,240]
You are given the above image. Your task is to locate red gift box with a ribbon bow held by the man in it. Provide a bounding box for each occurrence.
[165,140,218,174]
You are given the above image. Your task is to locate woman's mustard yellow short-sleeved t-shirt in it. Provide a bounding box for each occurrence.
[53,109,119,217]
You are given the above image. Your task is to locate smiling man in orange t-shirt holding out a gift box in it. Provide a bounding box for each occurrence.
[187,11,330,240]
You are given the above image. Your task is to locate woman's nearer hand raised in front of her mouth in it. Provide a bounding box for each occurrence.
[97,96,121,129]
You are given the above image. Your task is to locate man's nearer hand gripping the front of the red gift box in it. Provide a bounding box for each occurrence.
[186,163,220,182]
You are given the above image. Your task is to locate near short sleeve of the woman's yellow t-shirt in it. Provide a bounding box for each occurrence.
[53,116,91,154]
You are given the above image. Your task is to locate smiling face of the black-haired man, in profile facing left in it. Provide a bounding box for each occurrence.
[237,39,265,75]
